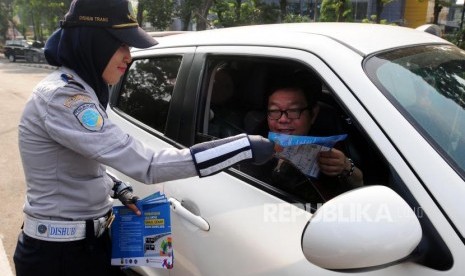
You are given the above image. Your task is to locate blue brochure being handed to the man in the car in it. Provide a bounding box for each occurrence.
[268,132,347,177]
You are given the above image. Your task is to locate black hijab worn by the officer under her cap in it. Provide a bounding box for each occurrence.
[45,27,122,108]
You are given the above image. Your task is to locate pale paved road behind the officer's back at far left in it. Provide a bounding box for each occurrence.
[0,55,53,276]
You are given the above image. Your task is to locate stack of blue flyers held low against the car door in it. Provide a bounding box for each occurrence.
[111,192,173,269]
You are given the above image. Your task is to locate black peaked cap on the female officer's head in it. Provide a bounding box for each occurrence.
[61,0,158,48]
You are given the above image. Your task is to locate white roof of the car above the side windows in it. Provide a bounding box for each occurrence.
[144,23,451,56]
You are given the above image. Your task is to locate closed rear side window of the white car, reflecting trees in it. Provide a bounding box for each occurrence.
[116,56,182,132]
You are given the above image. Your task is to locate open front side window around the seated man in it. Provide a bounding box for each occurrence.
[196,56,388,204]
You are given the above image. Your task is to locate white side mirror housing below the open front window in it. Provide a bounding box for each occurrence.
[302,186,422,270]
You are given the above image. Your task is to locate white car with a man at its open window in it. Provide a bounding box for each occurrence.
[108,23,465,276]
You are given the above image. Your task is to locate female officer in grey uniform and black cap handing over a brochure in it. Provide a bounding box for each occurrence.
[14,0,273,276]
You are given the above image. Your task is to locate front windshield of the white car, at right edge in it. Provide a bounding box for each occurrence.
[366,45,465,178]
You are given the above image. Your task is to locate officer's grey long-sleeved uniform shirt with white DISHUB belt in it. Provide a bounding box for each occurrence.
[15,68,197,274]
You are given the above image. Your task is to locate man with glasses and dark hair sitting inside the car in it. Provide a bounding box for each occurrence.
[242,71,363,203]
